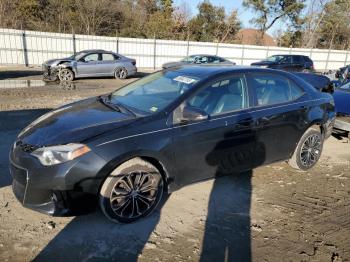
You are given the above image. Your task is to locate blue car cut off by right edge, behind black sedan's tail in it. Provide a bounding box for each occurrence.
[333,82,350,138]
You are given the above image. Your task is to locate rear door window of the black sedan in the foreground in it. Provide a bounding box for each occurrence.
[250,74,304,106]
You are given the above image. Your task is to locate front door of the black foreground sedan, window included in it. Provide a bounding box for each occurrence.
[173,74,255,186]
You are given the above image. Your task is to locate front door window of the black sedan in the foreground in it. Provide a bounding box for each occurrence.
[187,75,247,115]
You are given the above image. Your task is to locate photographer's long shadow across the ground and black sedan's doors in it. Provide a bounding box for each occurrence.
[200,130,266,262]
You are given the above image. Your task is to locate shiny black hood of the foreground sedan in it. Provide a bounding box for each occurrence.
[18,98,137,146]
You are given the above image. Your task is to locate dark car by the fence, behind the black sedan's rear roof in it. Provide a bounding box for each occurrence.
[251,55,315,72]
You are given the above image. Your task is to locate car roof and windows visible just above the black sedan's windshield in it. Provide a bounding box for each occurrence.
[162,55,236,69]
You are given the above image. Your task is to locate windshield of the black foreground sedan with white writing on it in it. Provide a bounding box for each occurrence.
[110,71,199,113]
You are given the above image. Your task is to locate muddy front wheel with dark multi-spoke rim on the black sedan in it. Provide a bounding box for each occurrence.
[99,158,164,223]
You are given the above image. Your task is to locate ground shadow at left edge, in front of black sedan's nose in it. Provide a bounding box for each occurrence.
[0,109,49,188]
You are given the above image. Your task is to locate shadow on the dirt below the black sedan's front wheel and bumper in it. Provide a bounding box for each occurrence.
[33,194,167,262]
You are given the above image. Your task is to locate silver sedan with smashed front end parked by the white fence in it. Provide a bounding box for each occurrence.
[43,50,137,81]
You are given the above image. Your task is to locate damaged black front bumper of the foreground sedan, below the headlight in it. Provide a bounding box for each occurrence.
[10,143,106,216]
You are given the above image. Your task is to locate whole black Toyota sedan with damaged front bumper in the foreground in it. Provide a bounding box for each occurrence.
[10,66,335,223]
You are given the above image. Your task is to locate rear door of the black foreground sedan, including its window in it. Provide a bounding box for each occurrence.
[247,73,307,163]
